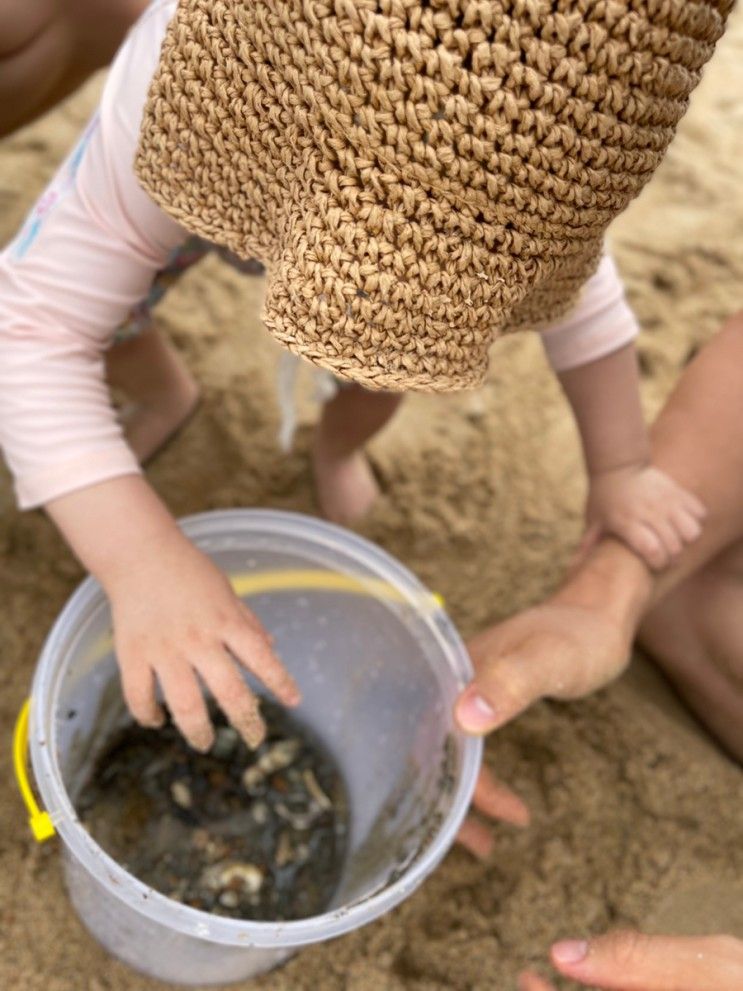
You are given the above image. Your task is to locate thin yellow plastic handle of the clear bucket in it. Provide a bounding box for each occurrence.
[13,570,443,843]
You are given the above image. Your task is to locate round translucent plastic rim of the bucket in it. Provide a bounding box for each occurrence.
[29,509,483,949]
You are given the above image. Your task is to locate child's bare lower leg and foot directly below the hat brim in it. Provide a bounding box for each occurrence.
[312,385,402,524]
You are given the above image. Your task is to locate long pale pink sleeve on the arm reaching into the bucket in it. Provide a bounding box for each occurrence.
[0,0,184,508]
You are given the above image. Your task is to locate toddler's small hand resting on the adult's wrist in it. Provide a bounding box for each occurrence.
[581,465,706,570]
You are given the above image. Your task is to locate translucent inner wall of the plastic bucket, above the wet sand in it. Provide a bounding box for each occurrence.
[41,520,462,936]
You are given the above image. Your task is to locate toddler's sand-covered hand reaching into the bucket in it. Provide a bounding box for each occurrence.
[107,531,300,751]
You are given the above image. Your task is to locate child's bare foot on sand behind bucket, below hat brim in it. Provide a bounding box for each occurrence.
[312,437,379,526]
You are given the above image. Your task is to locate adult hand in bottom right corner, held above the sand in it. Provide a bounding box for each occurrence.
[519,932,743,991]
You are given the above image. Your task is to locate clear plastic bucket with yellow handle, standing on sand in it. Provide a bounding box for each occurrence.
[24,510,482,985]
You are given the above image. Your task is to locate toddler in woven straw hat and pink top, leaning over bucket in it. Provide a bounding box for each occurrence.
[0,0,727,750]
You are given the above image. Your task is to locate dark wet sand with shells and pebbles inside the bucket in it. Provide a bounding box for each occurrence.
[77,701,348,921]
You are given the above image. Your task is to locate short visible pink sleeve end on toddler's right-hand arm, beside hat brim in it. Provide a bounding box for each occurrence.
[541,255,639,372]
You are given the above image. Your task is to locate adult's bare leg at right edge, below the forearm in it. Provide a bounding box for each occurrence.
[639,543,743,761]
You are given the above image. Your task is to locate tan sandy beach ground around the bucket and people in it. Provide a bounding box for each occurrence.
[0,10,743,991]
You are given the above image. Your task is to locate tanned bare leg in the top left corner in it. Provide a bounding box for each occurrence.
[0,0,147,137]
